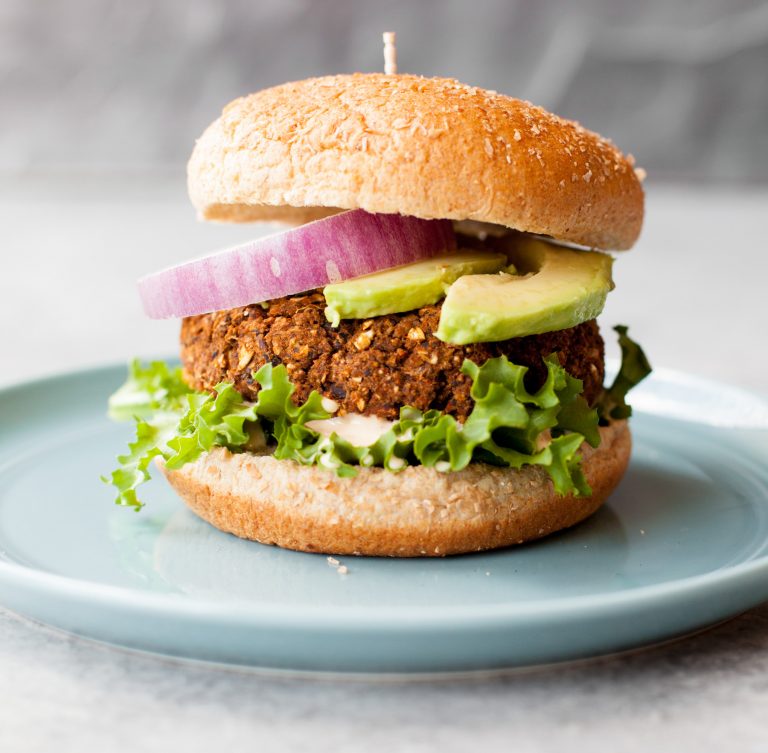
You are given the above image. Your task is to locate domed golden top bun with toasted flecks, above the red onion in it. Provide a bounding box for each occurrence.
[188,73,643,249]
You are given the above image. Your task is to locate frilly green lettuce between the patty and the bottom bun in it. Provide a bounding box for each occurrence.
[103,327,650,509]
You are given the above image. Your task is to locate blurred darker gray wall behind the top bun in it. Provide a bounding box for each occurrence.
[0,0,768,182]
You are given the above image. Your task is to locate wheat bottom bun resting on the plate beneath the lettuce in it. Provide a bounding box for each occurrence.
[163,421,631,557]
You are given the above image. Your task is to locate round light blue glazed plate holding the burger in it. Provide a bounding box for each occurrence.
[0,368,768,672]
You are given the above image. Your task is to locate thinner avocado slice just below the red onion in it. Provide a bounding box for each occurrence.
[323,250,513,326]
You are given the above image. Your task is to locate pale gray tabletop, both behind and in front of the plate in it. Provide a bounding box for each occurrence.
[0,179,768,753]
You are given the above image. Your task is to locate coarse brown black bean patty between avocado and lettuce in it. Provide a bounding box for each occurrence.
[181,292,603,420]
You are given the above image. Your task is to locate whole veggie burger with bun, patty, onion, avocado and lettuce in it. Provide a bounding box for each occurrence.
[105,74,650,557]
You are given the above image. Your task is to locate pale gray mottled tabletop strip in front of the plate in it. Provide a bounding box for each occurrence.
[0,607,768,753]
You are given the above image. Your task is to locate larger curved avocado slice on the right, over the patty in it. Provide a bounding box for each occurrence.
[435,236,613,345]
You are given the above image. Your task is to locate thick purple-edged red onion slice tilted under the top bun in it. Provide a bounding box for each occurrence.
[138,209,456,319]
